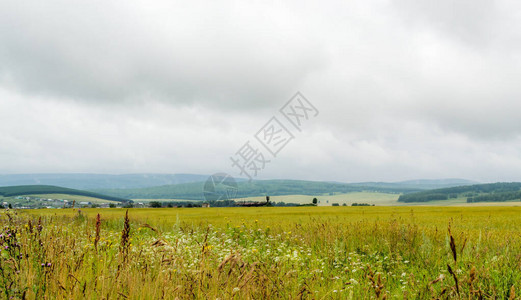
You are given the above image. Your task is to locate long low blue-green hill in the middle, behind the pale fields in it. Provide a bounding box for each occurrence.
[94,180,476,200]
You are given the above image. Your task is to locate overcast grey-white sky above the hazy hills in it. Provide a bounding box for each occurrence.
[0,0,521,182]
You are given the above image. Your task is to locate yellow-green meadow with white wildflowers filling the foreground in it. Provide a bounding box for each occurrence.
[0,206,521,299]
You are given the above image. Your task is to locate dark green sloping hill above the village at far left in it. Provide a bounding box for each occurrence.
[0,185,129,202]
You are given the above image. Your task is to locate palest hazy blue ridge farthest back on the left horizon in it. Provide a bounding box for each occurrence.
[0,174,208,190]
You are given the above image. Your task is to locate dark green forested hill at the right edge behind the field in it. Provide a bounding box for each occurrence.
[398,182,521,203]
